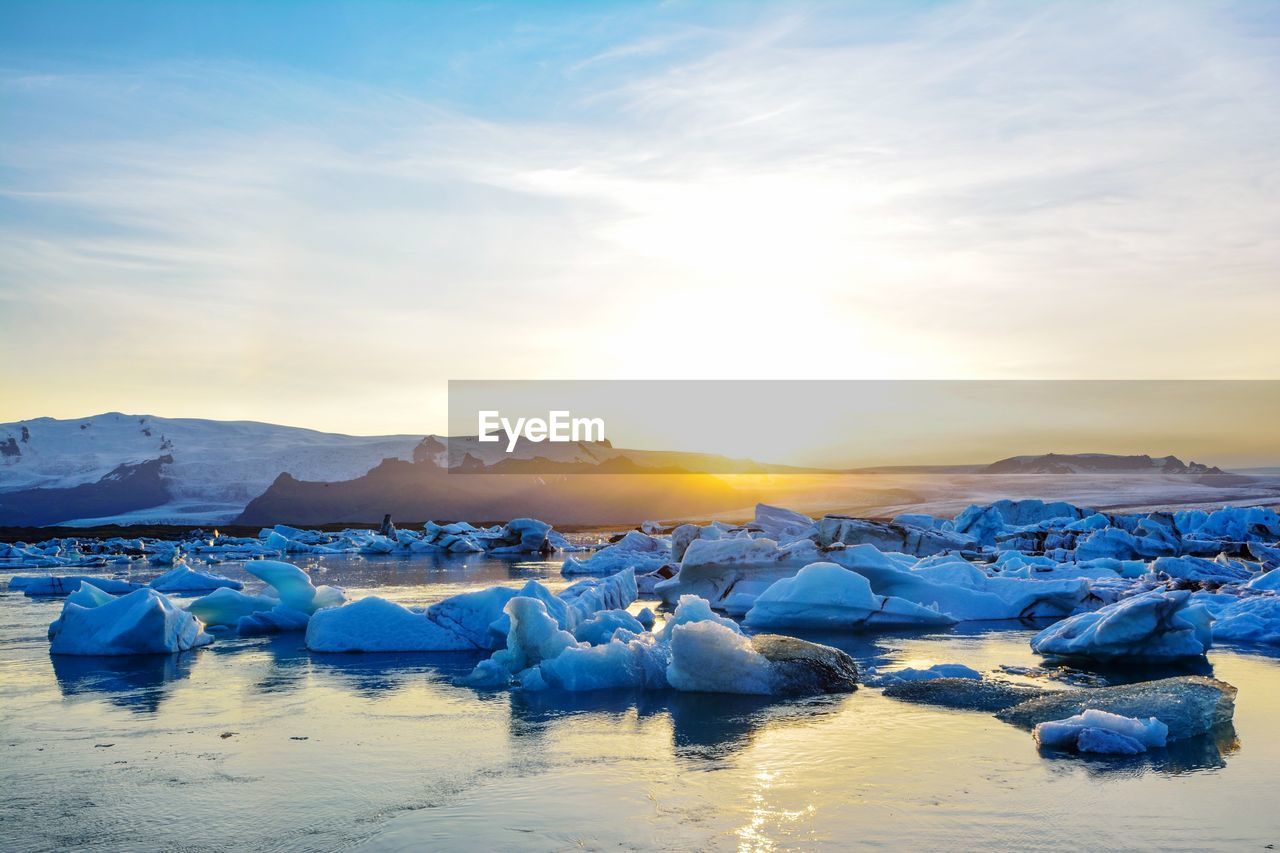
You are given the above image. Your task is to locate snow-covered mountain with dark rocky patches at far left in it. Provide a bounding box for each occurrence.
[0,412,422,524]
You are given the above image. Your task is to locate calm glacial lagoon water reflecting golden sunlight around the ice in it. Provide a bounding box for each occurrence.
[0,555,1280,850]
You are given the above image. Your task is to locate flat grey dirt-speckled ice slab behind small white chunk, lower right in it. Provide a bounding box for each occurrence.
[998,675,1235,740]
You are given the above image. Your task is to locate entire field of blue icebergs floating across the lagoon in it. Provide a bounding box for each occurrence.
[10,501,1280,754]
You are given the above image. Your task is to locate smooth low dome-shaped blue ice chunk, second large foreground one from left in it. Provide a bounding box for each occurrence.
[306,596,475,652]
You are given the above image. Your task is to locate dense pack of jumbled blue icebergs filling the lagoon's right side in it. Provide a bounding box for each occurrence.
[563,500,1280,648]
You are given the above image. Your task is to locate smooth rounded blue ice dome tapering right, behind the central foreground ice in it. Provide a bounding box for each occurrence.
[744,562,955,629]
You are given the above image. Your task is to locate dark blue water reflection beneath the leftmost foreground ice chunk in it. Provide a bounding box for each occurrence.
[49,652,197,713]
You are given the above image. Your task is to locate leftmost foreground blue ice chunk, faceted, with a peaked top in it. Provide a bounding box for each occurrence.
[49,589,212,654]
